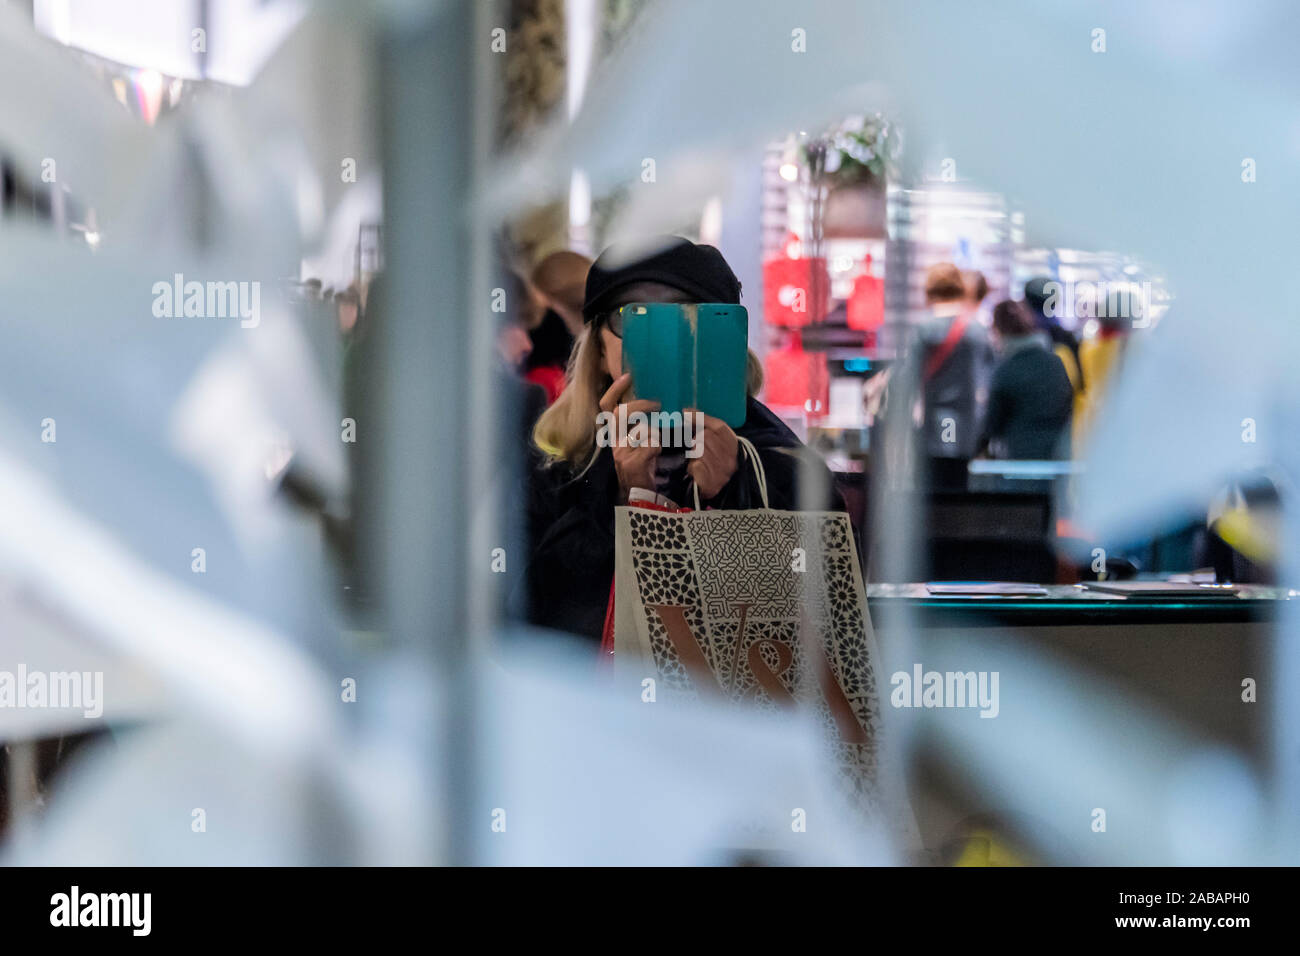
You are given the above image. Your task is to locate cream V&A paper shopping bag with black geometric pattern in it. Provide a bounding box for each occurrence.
[628,509,880,810]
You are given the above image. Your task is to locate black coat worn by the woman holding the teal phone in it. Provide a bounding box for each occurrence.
[528,398,844,641]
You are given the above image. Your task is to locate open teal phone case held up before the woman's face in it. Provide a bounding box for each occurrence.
[623,302,749,428]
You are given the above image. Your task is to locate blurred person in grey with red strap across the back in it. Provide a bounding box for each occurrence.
[919,263,993,489]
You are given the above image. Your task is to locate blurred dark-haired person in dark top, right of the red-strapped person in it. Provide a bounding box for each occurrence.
[979,299,1074,460]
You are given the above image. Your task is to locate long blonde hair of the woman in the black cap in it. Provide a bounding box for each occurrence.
[533,325,763,471]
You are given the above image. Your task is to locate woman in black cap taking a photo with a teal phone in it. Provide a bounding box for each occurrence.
[528,237,842,641]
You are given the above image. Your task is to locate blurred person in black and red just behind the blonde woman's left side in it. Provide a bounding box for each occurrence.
[524,250,592,402]
